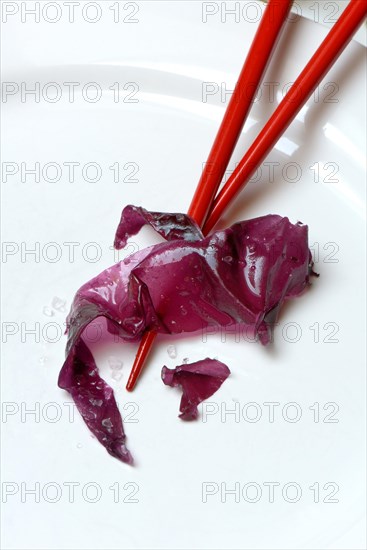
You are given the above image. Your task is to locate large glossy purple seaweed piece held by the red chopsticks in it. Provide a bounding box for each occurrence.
[59,206,313,463]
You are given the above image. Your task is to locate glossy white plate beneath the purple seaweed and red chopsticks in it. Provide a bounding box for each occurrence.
[2,2,366,549]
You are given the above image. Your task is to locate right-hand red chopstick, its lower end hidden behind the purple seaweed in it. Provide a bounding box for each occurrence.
[203,0,367,234]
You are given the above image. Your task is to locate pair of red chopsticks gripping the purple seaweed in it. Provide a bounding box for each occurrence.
[126,0,367,391]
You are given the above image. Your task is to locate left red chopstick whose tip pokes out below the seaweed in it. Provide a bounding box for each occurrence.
[126,0,293,391]
